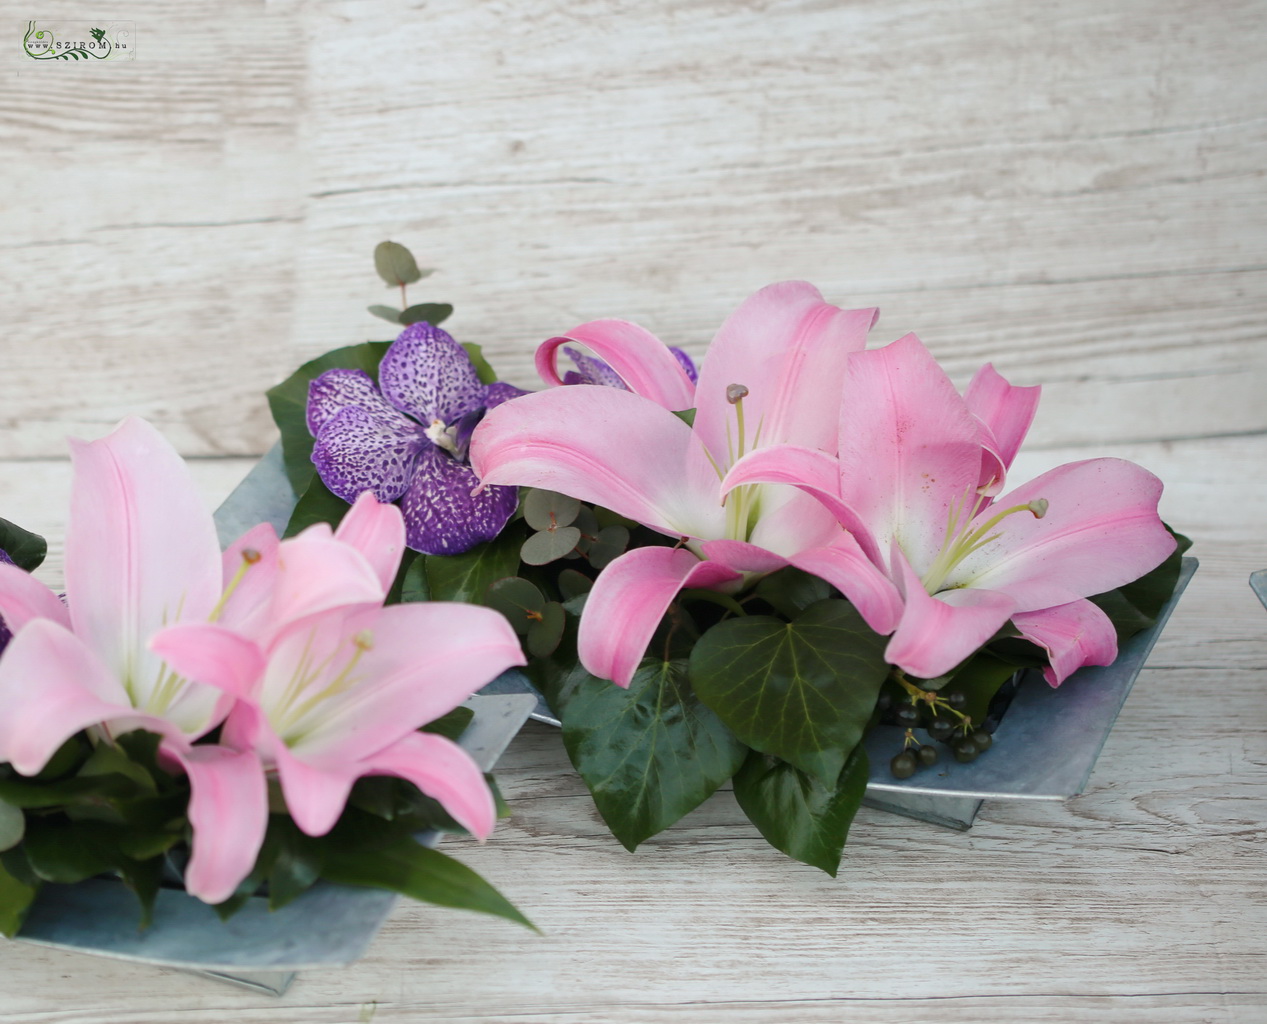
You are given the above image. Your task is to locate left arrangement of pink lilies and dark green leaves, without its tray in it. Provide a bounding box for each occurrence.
[0,418,526,935]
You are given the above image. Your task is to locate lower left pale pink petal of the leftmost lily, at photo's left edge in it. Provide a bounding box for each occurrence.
[0,618,184,776]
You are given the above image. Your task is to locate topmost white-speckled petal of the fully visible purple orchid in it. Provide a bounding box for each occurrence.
[379,323,484,426]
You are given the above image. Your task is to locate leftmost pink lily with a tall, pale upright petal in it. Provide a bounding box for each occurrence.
[0,418,403,901]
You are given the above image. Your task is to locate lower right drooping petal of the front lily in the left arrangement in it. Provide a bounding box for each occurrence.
[361,733,497,839]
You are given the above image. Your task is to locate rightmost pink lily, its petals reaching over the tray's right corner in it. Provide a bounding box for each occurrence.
[726,335,1175,686]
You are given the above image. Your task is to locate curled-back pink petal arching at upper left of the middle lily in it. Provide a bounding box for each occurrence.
[536,319,696,409]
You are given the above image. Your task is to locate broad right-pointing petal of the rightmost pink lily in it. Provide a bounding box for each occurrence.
[946,459,1175,612]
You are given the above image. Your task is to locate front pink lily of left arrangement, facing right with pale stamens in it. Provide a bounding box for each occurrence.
[153,582,525,901]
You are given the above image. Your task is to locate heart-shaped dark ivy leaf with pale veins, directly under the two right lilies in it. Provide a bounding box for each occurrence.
[691,599,888,786]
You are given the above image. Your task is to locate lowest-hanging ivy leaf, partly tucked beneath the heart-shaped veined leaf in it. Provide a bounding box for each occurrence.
[735,744,869,878]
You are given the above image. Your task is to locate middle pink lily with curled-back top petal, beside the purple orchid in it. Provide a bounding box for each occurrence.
[470,281,901,686]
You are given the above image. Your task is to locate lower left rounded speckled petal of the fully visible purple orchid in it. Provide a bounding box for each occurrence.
[313,406,432,502]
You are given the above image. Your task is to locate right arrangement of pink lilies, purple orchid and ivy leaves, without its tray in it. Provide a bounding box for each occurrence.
[270,242,1187,873]
